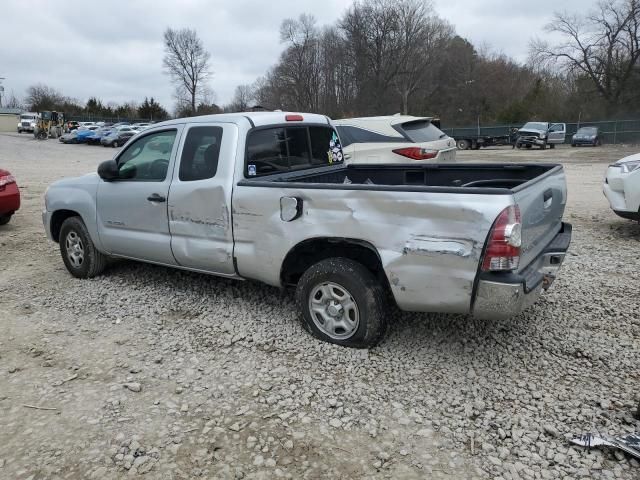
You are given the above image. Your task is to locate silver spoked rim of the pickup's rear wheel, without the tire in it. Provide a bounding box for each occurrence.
[309,282,360,340]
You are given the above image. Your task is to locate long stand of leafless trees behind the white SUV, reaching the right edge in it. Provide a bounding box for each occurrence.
[234,0,640,126]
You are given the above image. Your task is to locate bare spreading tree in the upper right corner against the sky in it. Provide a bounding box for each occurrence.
[530,0,640,108]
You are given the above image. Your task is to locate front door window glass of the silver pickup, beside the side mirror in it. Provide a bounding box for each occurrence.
[118,130,176,182]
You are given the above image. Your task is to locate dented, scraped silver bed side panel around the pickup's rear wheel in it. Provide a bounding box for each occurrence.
[233,186,512,313]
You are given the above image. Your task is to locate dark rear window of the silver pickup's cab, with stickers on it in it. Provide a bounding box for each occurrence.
[244,125,344,178]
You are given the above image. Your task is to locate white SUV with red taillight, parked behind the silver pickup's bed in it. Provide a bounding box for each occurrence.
[332,115,457,163]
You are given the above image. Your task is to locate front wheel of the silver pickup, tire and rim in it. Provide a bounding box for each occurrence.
[59,217,107,278]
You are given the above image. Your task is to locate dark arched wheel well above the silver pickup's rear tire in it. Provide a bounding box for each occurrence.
[280,238,388,286]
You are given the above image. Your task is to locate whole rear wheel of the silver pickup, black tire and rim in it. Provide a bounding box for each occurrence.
[296,257,388,348]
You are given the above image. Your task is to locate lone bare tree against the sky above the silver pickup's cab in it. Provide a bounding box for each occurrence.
[163,28,212,114]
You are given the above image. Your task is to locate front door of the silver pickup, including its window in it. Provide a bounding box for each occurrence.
[97,125,182,265]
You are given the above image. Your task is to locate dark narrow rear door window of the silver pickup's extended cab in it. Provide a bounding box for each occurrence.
[179,127,222,182]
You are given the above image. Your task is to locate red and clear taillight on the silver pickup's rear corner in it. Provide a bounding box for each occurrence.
[482,205,522,272]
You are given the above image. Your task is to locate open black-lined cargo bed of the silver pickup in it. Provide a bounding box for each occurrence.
[241,163,562,194]
